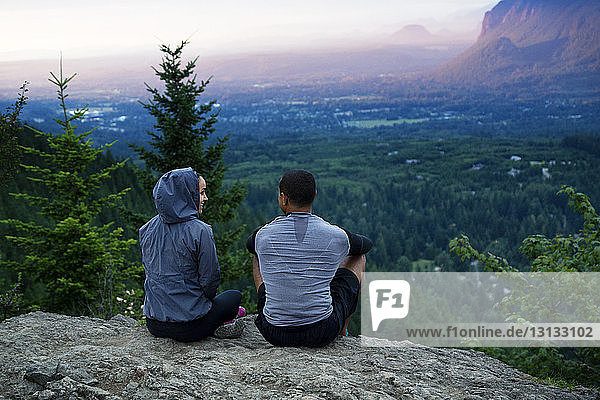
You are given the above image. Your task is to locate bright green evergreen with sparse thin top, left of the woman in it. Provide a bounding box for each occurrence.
[1,62,140,317]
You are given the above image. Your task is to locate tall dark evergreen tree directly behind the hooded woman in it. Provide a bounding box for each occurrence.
[130,41,251,281]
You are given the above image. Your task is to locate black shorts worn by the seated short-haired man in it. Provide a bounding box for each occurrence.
[254,268,360,347]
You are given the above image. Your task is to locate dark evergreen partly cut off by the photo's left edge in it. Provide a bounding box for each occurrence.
[0,82,27,186]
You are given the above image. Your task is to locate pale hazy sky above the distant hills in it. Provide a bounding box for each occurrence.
[0,0,496,61]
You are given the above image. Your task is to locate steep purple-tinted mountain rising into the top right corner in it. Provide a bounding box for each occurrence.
[432,0,600,91]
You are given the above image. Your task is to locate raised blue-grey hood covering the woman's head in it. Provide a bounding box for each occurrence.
[152,167,200,224]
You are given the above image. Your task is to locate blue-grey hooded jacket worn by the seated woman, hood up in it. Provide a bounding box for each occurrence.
[139,168,220,322]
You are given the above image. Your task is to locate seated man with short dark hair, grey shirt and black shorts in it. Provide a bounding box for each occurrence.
[246,170,372,347]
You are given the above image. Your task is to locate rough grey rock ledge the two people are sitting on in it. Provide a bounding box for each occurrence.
[0,312,600,400]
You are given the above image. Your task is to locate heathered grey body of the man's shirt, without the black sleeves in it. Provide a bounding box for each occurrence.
[252,213,352,326]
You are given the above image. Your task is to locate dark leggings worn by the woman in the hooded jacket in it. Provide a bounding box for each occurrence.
[146,290,242,342]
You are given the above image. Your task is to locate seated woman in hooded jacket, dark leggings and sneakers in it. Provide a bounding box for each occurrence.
[139,168,245,342]
